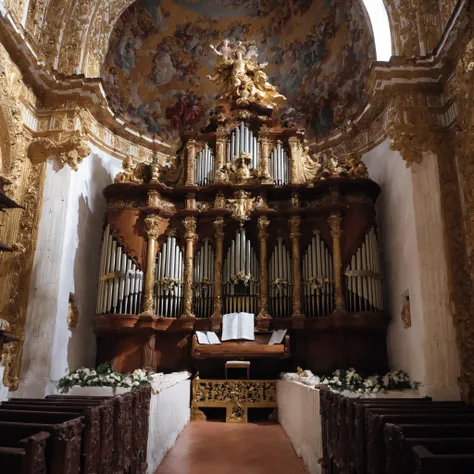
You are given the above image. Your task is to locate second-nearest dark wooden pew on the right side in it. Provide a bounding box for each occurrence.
[384,423,474,474]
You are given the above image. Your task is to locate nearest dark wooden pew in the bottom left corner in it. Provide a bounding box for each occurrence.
[0,431,51,474]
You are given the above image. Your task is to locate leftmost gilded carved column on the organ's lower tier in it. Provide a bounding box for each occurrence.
[141,214,164,316]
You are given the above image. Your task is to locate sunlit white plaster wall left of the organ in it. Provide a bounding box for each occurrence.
[14,147,121,397]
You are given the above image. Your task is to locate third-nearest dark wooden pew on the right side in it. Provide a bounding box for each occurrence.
[366,411,474,474]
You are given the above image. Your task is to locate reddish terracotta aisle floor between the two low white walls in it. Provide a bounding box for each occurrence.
[156,421,307,474]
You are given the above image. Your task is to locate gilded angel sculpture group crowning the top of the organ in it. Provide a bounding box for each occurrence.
[207,40,286,109]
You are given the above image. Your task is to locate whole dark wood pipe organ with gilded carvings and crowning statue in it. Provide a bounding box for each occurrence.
[94,42,388,380]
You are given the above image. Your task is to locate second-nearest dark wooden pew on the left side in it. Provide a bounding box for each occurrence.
[0,417,84,474]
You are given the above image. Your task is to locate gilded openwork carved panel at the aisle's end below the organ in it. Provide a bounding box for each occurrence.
[191,379,278,423]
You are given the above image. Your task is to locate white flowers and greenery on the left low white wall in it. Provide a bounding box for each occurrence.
[57,364,153,393]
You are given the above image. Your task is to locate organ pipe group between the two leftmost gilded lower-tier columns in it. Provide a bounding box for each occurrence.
[155,233,184,318]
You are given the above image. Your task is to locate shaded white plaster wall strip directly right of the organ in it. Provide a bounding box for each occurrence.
[363,142,425,381]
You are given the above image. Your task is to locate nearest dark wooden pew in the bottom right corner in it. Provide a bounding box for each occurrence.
[413,446,474,474]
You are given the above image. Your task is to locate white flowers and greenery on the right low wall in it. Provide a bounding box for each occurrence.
[319,368,420,393]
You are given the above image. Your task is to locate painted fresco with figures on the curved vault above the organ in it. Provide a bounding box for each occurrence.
[102,0,375,143]
